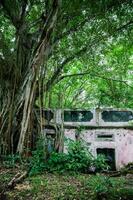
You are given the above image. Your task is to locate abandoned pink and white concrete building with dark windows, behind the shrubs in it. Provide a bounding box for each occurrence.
[42,109,133,170]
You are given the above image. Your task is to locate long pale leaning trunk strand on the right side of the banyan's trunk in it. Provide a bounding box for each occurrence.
[17,0,59,154]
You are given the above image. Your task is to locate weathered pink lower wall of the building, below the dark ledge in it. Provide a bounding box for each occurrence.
[64,128,133,169]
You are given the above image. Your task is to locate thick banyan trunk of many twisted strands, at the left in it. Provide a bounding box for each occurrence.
[0,0,59,154]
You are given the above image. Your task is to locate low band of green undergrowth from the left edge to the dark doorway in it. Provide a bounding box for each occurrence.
[0,138,109,175]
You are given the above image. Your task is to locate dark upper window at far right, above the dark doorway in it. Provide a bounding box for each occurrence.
[102,111,133,122]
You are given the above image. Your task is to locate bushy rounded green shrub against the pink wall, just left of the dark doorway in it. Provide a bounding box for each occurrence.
[46,141,107,173]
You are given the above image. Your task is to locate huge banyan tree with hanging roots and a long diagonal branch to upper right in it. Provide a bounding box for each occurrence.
[0,0,132,154]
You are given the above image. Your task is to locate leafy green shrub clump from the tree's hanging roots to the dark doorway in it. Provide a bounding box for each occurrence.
[29,139,107,175]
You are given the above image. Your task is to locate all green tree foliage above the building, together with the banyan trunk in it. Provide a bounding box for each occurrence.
[0,0,133,153]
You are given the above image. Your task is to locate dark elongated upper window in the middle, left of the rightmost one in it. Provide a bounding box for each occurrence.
[64,111,93,122]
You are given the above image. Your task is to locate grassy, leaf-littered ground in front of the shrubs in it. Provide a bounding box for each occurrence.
[0,167,133,200]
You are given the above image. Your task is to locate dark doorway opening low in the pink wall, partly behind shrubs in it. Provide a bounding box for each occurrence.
[97,148,116,170]
